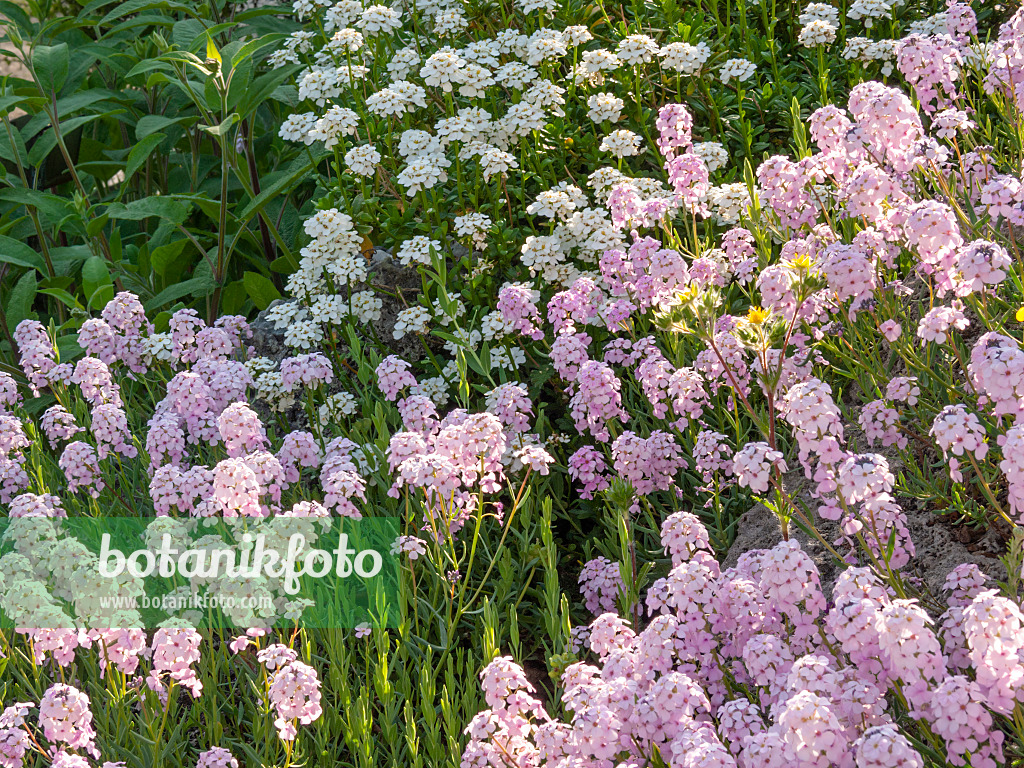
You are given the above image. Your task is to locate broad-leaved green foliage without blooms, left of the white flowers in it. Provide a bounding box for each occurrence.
[0,0,315,356]
